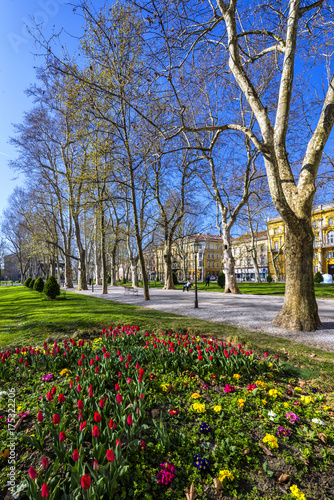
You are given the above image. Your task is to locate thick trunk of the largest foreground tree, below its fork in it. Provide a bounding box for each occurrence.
[274,221,321,332]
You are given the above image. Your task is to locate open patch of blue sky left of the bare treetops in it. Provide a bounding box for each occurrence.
[0,0,95,216]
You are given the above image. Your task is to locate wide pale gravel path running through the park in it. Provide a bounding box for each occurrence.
[64,286,334,353]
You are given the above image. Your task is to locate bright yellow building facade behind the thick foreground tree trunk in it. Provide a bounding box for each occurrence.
[267,203,334,281]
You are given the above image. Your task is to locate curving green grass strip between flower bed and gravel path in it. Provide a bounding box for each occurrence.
[0,286,334,390]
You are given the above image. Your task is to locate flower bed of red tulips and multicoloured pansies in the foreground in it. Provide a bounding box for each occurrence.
[0,326,334,500]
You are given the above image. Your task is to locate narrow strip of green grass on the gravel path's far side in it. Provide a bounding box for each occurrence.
[138,281,334,299]
